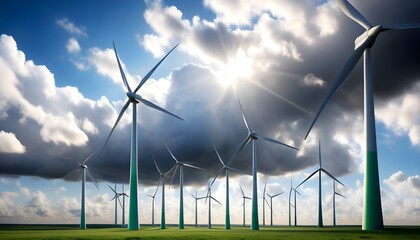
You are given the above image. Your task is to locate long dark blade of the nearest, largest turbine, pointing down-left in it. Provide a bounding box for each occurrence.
[305,37,370,139]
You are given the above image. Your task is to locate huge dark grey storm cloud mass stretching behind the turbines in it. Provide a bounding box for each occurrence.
[0,0,420,188]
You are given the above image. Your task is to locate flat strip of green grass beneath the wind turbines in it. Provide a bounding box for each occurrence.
[0,225,420,240]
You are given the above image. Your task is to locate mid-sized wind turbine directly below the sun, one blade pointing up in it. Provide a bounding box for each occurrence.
[227,94,299,230]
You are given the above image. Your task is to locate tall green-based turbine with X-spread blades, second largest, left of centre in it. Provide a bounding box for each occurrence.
[103,43,183,230]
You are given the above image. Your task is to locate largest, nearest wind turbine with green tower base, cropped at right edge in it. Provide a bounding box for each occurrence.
[305,0,420,230]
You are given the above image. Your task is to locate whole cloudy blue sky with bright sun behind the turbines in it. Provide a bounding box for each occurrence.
[0,0,420,225]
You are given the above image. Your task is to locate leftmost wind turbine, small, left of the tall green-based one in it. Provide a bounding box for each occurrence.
[63,148,99,229]
